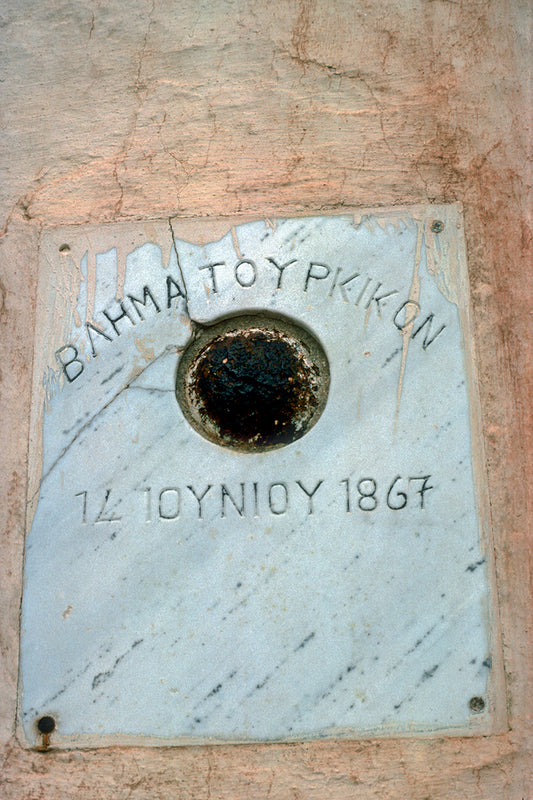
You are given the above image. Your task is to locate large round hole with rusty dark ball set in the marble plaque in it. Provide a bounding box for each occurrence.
[176,313,329,452]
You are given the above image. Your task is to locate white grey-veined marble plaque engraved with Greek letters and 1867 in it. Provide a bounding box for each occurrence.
[19,206,503,747]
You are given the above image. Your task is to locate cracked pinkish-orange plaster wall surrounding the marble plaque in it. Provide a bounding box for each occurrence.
[0,0,533,800]
